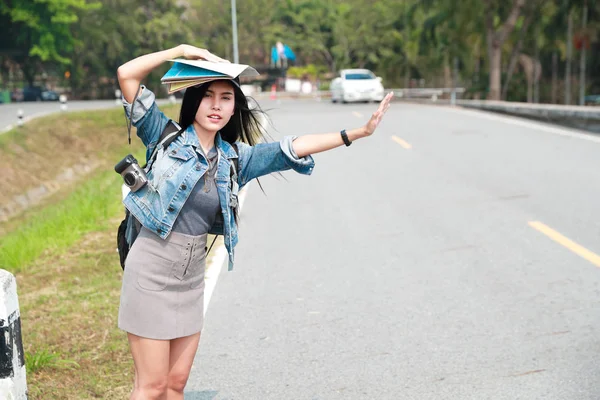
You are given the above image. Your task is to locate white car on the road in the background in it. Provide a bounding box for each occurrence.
[330,69,384,103]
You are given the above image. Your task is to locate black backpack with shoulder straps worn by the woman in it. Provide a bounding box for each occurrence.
[117,120,239,270]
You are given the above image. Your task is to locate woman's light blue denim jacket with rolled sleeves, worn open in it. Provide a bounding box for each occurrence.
[123,88,314,270]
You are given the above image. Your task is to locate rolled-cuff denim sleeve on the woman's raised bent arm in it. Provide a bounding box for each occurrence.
[122,85,169,159]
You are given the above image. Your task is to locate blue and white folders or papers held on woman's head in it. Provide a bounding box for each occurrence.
[161,58,259,94]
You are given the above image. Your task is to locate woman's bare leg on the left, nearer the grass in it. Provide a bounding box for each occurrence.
[127,333,170,400]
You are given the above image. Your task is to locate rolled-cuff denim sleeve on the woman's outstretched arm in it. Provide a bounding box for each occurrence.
[237,136,315,187]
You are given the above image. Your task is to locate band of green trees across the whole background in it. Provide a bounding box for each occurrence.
[0,0,600,101]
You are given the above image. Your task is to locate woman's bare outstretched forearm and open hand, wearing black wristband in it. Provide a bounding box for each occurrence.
[292,92,394,158]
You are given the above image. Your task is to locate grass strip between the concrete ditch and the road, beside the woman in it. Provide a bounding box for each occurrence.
[11,165,132,400]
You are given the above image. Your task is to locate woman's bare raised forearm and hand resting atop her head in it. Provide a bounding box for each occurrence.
[117,44,229,103]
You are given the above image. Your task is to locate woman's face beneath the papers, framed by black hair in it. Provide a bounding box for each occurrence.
[196,81,235,132]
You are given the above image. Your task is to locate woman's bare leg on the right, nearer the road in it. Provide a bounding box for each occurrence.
[167,332,200,400]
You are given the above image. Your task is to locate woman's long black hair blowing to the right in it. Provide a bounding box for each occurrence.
[179,79,268,146]
